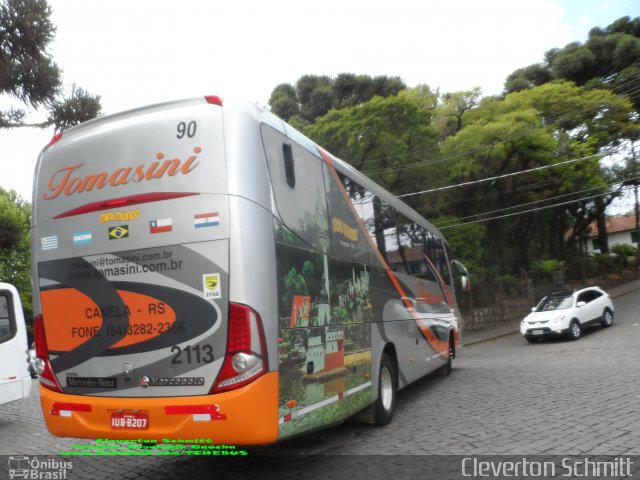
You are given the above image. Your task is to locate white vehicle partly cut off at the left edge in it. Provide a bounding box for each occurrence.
[0,283,31,404]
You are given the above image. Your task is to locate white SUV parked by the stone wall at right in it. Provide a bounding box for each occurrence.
[520,287,614,342]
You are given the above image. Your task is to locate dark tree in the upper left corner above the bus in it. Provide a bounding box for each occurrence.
[0,0,100,131]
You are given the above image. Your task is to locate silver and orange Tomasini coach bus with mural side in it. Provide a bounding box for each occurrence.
[32,96,466,445]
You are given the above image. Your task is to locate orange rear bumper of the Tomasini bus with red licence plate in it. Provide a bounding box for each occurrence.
[40,372,278,445]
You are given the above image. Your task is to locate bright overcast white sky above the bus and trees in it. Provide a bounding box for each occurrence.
[0,0,640,201]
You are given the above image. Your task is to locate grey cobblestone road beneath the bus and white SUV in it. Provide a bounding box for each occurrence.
[0,290,640,480]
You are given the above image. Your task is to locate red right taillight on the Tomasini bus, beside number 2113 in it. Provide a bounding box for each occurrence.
[211,303,268,393]
